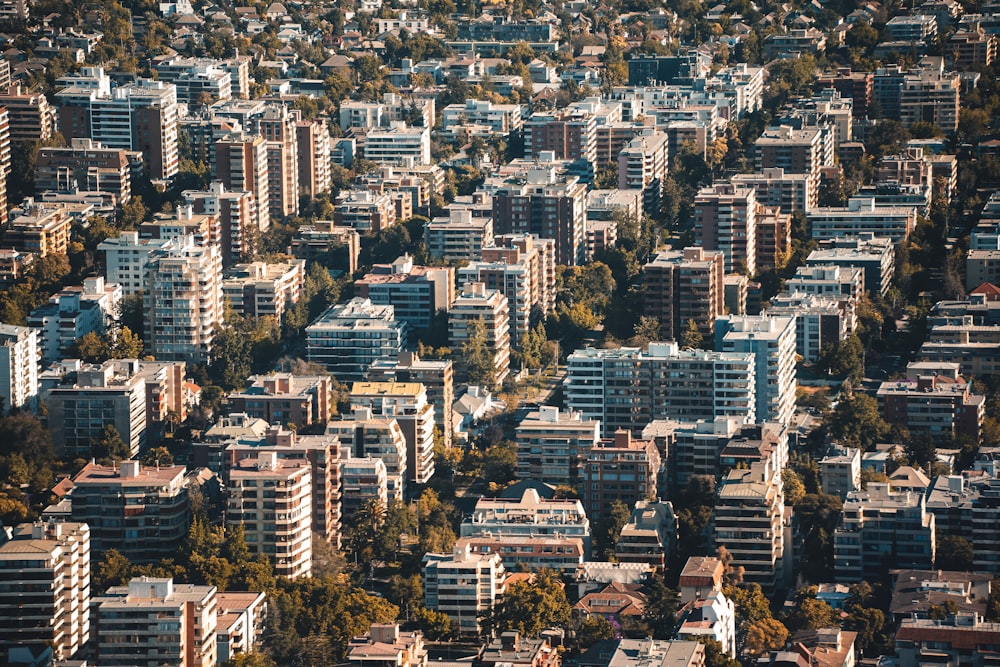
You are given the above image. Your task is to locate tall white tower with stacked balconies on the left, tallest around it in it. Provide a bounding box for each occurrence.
[143,236,223,361]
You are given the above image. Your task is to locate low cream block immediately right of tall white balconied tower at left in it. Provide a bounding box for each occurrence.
[222,259,306,321]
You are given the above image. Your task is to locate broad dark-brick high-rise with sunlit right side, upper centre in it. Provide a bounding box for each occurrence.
[493,165,587,265]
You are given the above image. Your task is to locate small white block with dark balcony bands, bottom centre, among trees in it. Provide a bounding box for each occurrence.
[423,545,507,637]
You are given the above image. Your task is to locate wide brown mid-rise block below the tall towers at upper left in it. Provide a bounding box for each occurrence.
[34,138,133,206]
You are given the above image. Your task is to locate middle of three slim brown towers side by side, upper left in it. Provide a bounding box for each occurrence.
[257,105,299,220]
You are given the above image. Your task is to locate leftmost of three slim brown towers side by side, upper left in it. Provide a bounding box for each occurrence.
[215,134,274,232]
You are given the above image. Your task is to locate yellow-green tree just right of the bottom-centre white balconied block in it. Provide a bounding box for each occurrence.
[483,570,571,637]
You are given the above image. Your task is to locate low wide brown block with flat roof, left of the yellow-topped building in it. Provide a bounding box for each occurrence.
[226,373,333,428]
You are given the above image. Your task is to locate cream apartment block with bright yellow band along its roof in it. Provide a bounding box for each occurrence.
[351,382,434,484]
